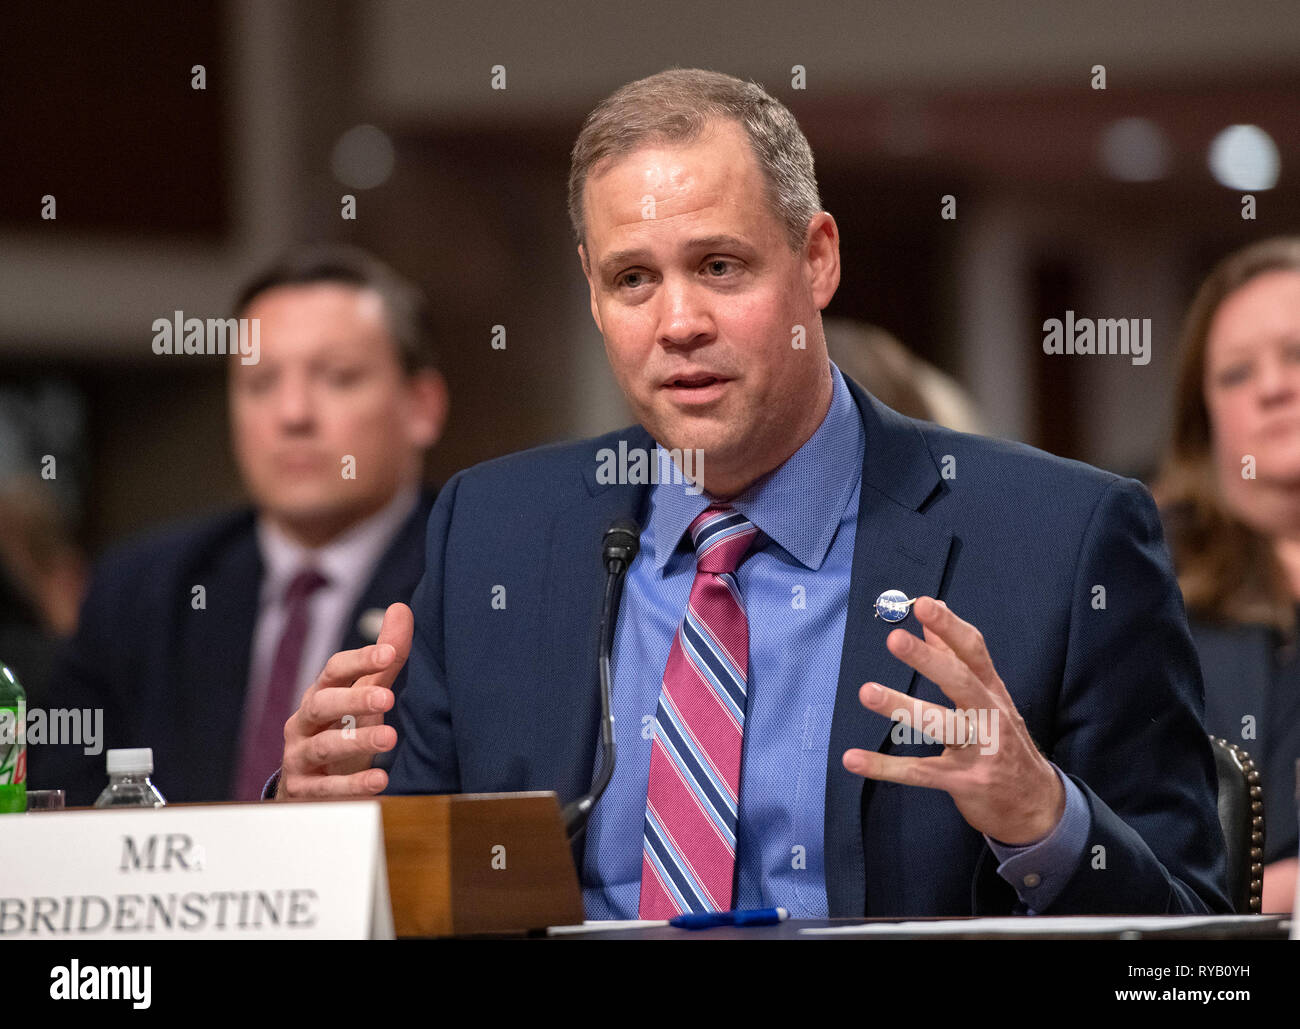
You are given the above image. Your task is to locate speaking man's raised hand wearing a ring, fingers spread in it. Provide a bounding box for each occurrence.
[844,596,1065,846]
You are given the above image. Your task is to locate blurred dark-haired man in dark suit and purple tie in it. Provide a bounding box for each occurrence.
[31,248,447,804]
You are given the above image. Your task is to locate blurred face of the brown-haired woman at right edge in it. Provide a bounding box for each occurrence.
[1205,272,1300,524]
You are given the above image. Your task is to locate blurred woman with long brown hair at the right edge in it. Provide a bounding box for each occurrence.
[1154,238,1300,912]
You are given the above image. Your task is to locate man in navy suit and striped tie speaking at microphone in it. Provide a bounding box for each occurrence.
[280,70,1229,917]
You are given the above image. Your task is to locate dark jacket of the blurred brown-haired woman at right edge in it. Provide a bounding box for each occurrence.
[1191,618,1300,864]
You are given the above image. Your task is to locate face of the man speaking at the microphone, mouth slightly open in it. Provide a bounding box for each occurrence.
[580,121,840,495]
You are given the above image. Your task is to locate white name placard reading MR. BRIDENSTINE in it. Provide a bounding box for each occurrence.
[0,802,393,941]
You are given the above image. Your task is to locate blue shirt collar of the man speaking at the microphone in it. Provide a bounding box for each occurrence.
[650,364,866,572]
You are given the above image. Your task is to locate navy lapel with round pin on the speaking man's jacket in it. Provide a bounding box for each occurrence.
[826,379,953,917]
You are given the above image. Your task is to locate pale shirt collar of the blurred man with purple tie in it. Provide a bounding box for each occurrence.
[257,485,420,603]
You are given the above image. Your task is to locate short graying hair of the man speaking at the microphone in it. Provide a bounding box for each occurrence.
[568,68,822,251]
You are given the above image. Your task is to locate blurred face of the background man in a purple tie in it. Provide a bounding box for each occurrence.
[230,283,445,544]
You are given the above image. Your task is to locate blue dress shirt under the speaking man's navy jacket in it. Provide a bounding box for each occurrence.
[582,365,1089,919]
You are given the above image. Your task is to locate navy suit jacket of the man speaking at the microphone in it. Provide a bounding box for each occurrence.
[389,383,1231,916]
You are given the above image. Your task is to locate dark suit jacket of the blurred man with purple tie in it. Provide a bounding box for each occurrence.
[27,491,433,806]
